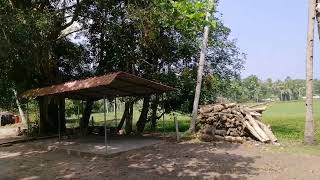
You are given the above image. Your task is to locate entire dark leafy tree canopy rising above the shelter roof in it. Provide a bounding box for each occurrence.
[0,0,245,132]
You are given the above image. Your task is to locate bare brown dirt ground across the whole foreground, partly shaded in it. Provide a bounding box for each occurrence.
[0,142,320,180]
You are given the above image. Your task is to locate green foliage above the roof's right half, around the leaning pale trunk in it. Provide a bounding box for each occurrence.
[83,0,245,113]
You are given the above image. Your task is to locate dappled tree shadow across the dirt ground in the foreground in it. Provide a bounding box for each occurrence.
[0,143,260,180]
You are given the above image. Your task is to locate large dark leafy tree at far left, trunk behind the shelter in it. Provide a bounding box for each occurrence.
[0,0,90,133]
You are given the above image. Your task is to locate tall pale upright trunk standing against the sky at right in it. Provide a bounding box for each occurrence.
[304,0,316,144]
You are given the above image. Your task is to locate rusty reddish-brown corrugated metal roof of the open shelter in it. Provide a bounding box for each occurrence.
[21,72,175,99]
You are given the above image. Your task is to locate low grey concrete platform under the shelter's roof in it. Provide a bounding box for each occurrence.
[32,136,162,157]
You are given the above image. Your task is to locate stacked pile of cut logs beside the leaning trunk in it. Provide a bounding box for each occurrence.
[198,103,277,143]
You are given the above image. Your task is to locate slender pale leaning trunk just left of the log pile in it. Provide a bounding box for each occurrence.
[189,1,213,133]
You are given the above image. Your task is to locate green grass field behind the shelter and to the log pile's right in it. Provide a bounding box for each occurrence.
[63,100,320,155]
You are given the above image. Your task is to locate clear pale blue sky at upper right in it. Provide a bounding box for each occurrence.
[218,0,320,79]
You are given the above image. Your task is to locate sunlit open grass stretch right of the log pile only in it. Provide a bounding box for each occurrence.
[263,100,320,155]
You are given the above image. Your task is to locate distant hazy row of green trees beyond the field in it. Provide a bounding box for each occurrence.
[223,75,308,102]
